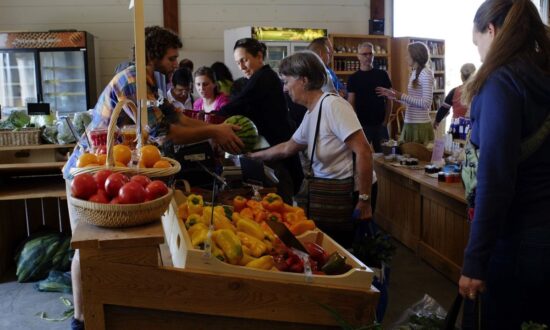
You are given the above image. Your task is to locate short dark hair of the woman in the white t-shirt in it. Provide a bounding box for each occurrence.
[279,51,327,90]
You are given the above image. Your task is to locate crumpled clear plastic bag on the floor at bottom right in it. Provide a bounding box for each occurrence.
[390,294,454,330]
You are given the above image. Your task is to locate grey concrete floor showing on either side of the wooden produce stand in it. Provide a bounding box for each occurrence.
[0,243,457,330]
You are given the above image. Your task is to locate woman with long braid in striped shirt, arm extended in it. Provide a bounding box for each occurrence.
[376,42,434,144]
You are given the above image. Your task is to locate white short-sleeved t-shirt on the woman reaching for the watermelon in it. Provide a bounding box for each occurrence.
[292,93,362,179]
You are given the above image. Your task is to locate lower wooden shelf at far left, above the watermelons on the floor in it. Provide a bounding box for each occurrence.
[0,176,67,201]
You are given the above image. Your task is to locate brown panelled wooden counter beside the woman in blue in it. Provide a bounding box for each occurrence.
[374,159,469,281]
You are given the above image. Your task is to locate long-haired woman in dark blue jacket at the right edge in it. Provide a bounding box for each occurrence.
[459,0,550,329]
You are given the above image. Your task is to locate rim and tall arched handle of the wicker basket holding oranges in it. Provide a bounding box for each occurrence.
[70,100,181,178]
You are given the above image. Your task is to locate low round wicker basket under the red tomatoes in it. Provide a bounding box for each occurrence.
[67,189,173,228]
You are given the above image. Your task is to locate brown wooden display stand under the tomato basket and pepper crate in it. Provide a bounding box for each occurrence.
[72,218,378,330]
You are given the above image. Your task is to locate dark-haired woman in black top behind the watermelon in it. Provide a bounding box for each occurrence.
[220,38,303,202]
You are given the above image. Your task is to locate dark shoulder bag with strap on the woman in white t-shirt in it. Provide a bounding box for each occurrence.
[301,95,355,230]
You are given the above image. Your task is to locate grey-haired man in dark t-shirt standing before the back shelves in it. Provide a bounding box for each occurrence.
[348,42,391,152]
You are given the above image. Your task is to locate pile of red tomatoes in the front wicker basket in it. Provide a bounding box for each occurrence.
[71,170,168,204]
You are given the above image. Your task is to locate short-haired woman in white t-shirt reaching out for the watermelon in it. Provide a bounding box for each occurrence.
[251,52,372,246]
